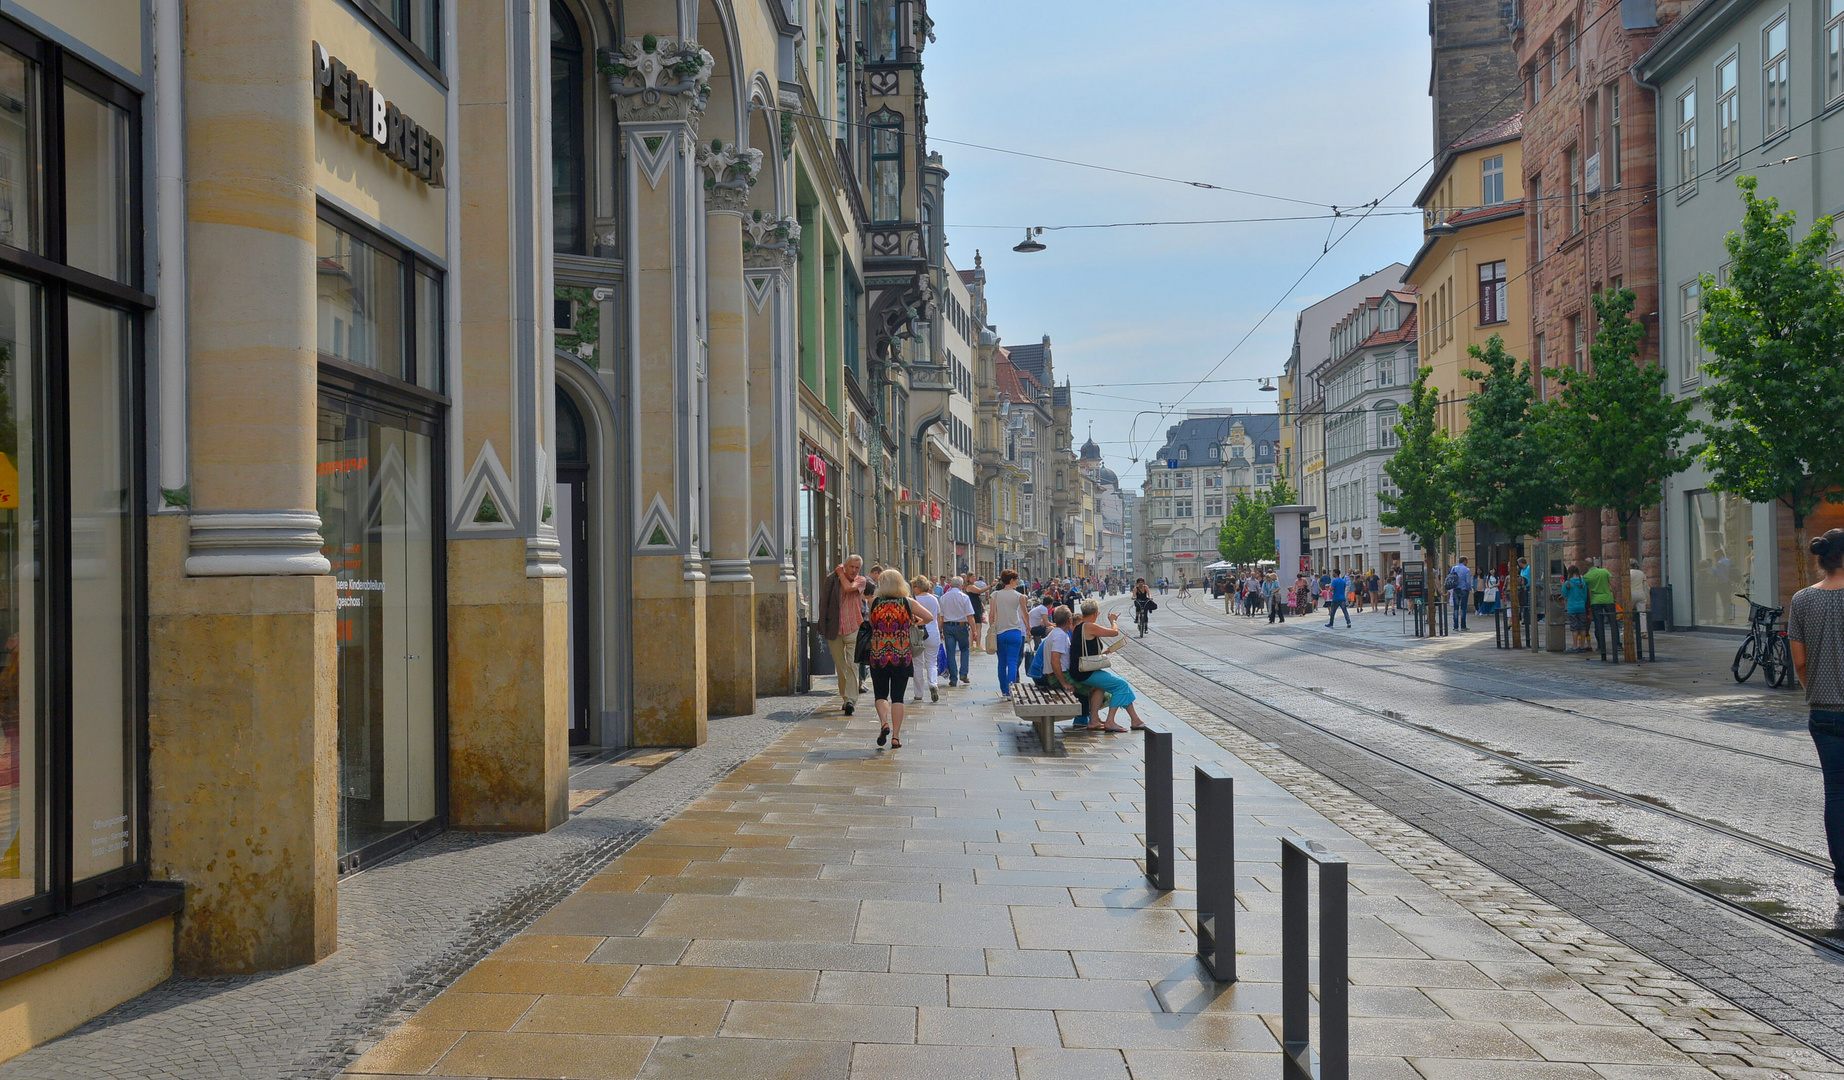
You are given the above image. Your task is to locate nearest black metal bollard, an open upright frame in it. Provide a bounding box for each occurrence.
[1280,837,1352,1080]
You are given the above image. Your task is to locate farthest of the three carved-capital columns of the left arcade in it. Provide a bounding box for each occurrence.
[743,210,800,695]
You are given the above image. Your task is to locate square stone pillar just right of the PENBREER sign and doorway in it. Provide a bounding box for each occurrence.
[448,0,570,831]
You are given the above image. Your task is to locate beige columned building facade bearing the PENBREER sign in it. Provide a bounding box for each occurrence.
[0,0,848,1056]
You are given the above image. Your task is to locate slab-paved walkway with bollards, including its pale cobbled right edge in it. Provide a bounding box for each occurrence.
[345,656,1844,1080]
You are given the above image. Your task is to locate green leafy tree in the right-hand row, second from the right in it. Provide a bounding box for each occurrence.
[1551,289,1696,660]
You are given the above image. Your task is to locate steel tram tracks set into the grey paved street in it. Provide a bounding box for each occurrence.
[1099,589,1844,957]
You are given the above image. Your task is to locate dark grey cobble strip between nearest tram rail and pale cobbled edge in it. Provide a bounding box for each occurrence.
[1129,630,1844,1061]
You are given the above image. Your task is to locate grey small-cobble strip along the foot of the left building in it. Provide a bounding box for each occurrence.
[0,693,824,1080]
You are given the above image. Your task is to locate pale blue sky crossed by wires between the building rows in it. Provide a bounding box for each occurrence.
[924,0,1433,487]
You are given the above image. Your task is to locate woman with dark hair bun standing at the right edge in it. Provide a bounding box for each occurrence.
[1787,529,1844,909]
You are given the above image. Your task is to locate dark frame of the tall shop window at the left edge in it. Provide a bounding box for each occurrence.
[0,18,153,932]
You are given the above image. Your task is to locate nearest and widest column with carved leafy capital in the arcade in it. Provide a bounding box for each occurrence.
[609,33,712,746]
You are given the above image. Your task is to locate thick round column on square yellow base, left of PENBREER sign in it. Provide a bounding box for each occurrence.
[148,0,337,975]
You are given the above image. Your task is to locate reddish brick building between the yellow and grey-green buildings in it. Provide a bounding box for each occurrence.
[1512,0,1693,584]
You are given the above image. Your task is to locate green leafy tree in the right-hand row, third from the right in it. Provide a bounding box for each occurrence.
[1453,334,1569,637]
